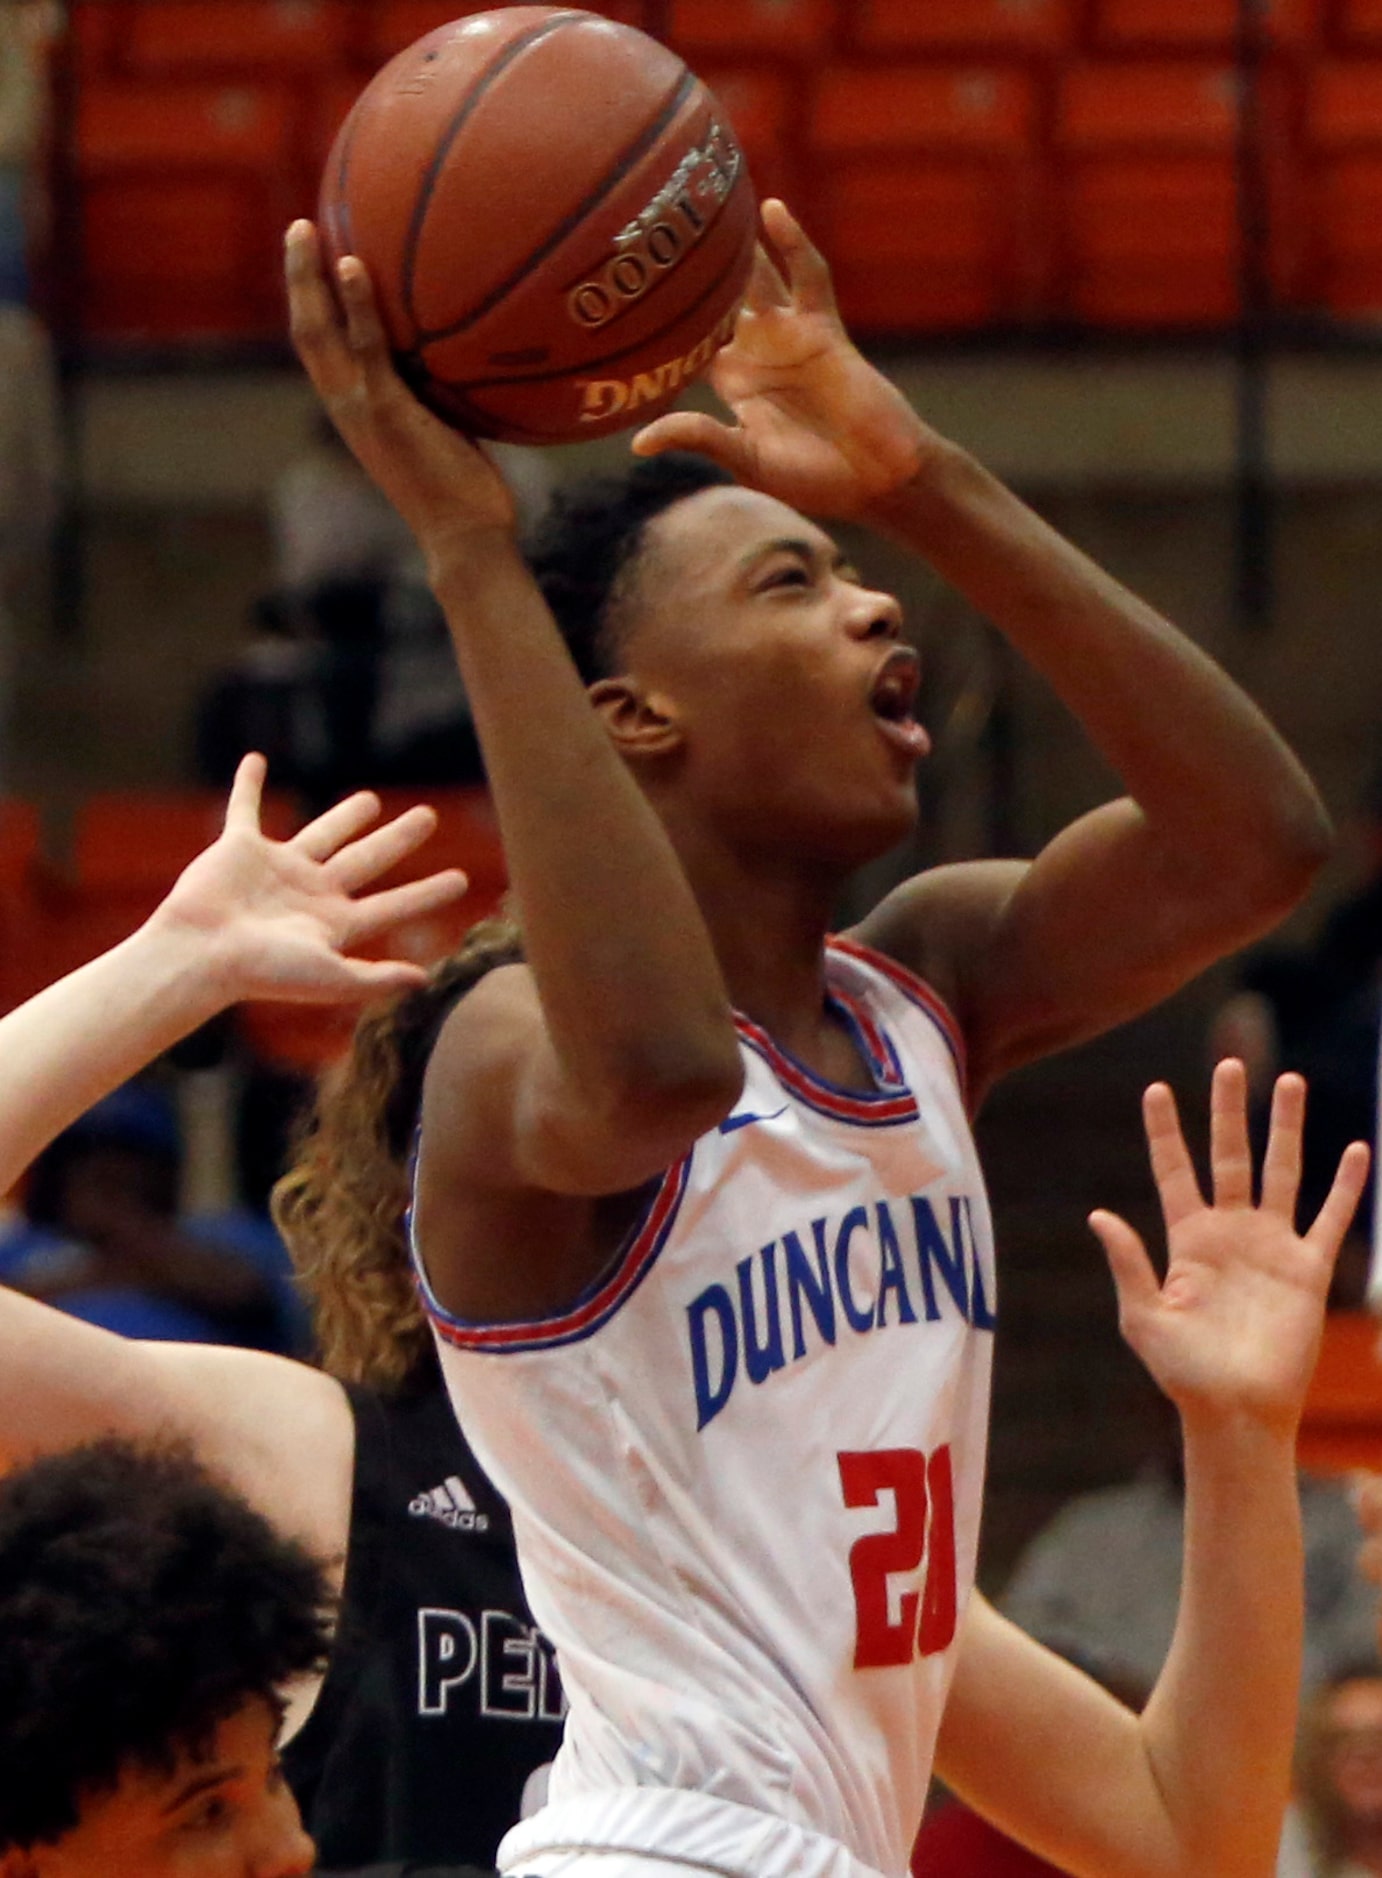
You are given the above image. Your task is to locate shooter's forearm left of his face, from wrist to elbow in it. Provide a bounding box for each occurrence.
[434,535,738,1099]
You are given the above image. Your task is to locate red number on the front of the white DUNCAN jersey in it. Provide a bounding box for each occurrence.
[839,1446,956,1670]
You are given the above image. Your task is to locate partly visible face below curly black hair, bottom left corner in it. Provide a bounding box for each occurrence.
[13,1701,314,1878]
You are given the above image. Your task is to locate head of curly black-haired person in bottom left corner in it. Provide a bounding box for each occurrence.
[0,1440,330,1878]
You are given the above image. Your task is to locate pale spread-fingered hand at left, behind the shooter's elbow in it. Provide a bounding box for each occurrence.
[148,755,466,1003]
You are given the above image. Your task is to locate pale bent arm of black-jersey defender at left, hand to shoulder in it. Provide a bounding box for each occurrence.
[0,757,466,1549]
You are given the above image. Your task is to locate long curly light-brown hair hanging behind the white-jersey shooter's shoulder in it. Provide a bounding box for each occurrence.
[272,918,524,1390]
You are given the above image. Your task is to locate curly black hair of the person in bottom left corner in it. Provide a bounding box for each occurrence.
[0,1439,332,1854]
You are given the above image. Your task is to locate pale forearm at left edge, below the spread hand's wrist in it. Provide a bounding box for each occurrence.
[0,920,229,1193]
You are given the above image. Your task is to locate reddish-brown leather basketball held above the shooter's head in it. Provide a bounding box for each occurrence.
[319,6,757,443]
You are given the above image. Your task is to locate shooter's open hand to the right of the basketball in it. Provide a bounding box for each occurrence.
[633,199,941,520]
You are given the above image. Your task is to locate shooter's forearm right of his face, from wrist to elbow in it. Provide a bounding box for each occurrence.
[871,445,1329,903]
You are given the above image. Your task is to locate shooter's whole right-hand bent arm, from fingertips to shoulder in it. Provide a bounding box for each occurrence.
[635,203,1331,1091]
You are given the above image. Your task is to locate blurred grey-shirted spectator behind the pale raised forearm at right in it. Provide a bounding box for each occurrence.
[999,1397,1378,1690]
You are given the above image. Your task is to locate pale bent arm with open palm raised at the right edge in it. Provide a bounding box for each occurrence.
[937,1061,1369,1878]
